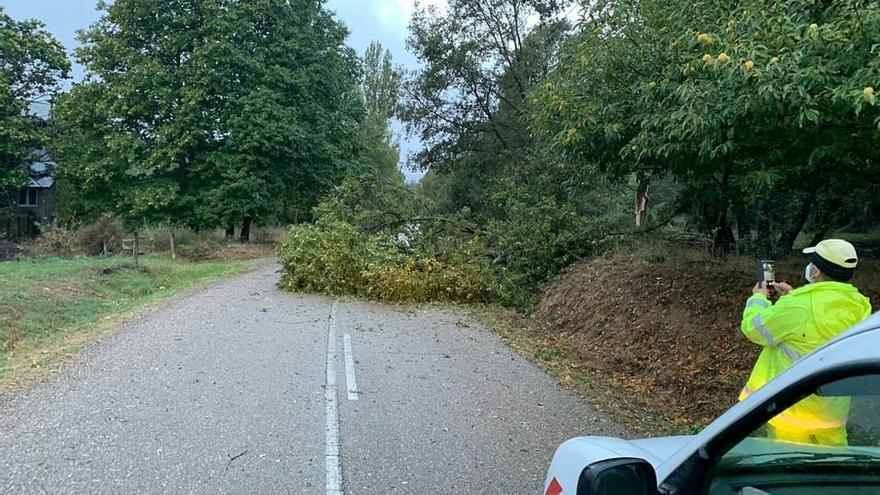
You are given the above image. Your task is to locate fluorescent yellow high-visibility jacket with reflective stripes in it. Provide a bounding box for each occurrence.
[740,282,871,444]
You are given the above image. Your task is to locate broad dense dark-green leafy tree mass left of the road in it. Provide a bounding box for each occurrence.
[53,0,363,241]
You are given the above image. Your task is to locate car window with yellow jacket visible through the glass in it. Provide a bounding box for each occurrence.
[707,375,880,495]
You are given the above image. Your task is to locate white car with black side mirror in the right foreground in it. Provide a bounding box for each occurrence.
[544,313,880,495]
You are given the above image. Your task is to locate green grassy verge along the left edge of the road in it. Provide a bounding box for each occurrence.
[0,256,250,391]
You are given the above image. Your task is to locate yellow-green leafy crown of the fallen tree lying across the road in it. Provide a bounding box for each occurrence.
[278,175,500,303]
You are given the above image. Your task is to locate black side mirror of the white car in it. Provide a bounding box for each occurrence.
[577,459,657,495]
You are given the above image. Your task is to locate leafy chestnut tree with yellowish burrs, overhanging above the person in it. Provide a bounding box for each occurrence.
[533,0,880,255]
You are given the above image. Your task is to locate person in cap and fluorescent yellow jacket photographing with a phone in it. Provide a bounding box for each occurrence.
[740,239,871,446]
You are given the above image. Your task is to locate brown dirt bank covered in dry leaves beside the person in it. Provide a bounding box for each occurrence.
[537,249,880,426]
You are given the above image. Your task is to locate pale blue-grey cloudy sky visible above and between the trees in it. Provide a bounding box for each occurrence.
[2,0,434,181]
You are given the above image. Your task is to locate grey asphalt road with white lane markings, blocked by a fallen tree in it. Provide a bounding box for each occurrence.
[0,265,619,495]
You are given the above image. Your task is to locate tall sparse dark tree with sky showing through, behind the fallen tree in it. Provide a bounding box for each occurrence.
[404,0,569,214]
